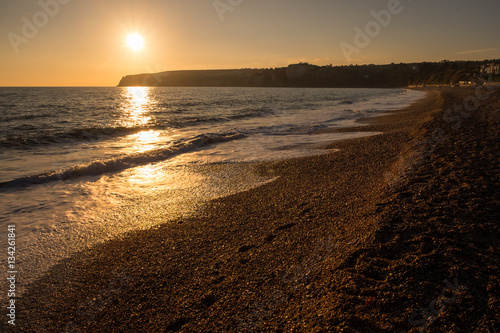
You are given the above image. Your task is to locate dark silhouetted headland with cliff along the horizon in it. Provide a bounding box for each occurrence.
[118,61,500,88]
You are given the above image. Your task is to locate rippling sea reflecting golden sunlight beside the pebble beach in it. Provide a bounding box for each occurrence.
[0,87,424,290]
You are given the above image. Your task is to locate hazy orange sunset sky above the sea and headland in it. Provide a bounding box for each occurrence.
[0,0,500,86]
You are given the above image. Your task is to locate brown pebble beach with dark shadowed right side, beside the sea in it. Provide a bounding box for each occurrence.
[5,88,500,332]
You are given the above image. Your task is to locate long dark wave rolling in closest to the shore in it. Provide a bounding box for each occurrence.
[0,133,245,189]
